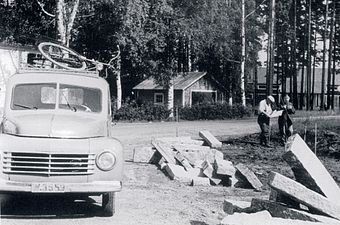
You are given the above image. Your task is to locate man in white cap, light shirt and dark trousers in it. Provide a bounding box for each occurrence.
[257,95,275,147]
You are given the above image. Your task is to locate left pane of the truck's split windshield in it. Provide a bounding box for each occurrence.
[11,83,57,110]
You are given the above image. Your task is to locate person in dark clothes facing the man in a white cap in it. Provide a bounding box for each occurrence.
[278,95,295,144]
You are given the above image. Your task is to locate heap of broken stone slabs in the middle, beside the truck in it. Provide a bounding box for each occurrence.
[133,130,262,191]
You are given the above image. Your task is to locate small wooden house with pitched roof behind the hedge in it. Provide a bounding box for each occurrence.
[133,72,226,107]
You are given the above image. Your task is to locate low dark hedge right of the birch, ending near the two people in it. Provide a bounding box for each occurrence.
[179,103,252,120]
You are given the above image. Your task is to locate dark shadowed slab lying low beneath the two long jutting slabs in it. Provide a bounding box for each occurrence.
[251,198,319,222]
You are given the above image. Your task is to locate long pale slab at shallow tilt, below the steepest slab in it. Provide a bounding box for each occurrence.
[268,172,340,219]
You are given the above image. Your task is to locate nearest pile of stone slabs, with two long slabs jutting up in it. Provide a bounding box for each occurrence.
[221,134,340,225]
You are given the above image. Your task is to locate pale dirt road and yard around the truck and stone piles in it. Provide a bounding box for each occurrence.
[0,119,262,225]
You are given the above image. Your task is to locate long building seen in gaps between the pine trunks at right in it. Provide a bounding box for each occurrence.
[247,67,340,107]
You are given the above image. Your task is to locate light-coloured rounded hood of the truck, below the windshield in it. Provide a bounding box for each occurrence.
[6,113,106,138]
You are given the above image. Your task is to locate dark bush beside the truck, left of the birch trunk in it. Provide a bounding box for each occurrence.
[113,102,170,121]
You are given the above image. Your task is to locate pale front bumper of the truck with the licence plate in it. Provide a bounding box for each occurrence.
[0,181,122,194]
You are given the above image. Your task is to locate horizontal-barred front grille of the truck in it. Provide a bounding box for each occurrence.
[3,152,95,176]
